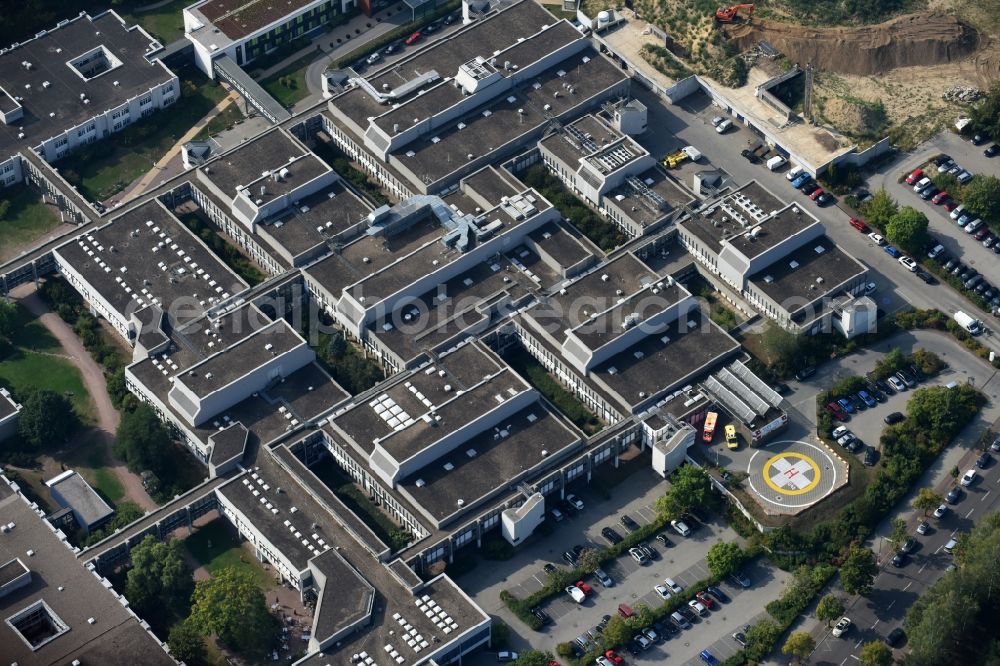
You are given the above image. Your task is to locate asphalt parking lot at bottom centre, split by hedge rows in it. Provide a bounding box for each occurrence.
[457,456,788,664]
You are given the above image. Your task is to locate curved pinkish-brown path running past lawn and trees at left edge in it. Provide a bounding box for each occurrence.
[10,284,157,511]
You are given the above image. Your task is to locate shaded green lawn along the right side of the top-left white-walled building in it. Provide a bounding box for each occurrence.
[56,75,226,201]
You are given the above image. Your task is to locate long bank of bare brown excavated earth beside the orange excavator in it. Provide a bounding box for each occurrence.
[726,12,980,75]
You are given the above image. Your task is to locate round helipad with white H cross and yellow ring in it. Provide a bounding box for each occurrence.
[747,440,848,514]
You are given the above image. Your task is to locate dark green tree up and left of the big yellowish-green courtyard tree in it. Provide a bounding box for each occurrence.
[125,534,194,615]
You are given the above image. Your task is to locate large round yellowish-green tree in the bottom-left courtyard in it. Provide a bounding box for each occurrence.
[190,567,278,655]
